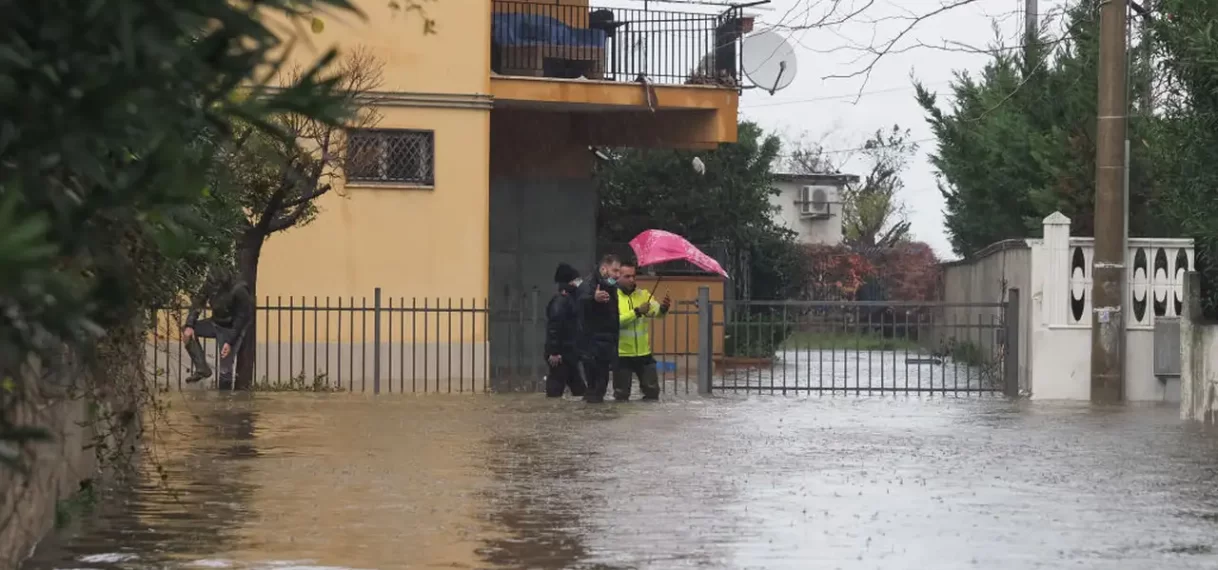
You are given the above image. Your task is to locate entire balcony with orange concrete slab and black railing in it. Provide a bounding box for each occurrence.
[491,0,753,149]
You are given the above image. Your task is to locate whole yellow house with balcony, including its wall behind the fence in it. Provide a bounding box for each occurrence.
[157,0,752,391]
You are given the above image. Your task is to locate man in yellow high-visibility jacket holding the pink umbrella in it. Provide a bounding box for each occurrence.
[613,263,672,402]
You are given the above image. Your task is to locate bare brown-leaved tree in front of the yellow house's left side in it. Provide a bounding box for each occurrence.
[217,48,384,390]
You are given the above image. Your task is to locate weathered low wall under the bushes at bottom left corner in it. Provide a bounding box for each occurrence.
[0,326,147,569]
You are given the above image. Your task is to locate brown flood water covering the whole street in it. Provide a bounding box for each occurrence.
[26,393,1218,570]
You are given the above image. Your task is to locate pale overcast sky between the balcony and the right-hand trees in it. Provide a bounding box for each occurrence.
[741,0,1061,258]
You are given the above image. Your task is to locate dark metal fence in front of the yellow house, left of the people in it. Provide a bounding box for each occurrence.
[146,290,542,393]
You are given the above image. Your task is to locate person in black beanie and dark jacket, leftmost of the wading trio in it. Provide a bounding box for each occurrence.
[546,263,586,398]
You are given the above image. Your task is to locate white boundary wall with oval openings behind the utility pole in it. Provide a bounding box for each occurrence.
[944,213,1194,402]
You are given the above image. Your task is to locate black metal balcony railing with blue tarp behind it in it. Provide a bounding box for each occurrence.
[491,0,750,89]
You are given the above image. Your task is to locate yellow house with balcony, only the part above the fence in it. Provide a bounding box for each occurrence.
[257,0,742,300]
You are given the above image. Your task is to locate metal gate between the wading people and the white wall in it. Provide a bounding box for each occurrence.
[653,290,1019,396]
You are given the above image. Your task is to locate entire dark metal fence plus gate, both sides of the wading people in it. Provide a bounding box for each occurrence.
[147,287,1019,395]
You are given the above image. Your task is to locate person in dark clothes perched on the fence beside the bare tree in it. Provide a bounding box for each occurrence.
[181,268,255,390]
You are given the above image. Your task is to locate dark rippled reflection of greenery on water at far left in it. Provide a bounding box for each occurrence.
[25,395,258,569]
